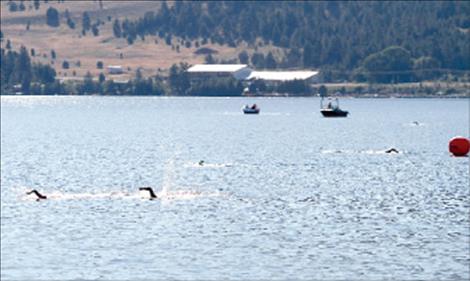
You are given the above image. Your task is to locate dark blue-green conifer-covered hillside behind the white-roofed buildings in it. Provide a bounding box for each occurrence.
[115,1,470,75]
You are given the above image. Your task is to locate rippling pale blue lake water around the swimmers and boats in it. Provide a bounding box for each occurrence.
[1,96,470,280]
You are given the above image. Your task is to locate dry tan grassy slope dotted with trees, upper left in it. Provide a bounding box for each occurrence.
[1,1,269,78]
